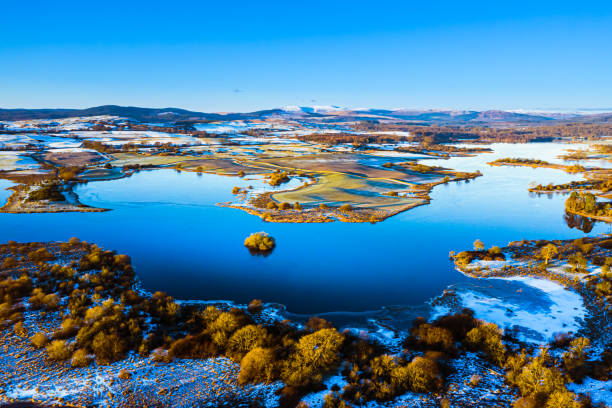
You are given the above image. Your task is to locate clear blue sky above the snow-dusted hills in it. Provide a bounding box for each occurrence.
[0,0,612,111]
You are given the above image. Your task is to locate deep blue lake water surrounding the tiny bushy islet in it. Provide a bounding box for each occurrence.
[0,144,610,314]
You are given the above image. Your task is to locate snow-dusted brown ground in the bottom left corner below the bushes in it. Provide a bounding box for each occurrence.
[0,307,282,408]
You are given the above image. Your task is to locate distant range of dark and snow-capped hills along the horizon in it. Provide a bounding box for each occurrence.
[0,105,612,125]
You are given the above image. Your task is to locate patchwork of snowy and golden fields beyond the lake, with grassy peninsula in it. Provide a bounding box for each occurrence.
[0,116,477,222]
